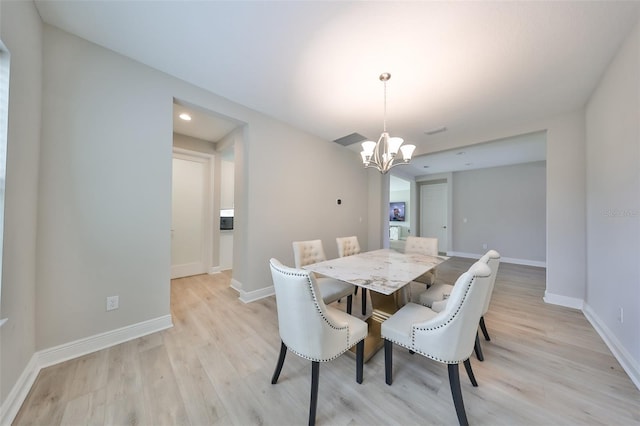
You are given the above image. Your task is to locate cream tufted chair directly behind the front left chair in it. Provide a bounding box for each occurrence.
[293,240,355,314]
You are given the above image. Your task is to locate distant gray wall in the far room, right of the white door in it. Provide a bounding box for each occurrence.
[452,162,546,264]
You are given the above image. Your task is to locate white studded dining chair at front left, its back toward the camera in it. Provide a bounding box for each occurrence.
[269,259,368,425]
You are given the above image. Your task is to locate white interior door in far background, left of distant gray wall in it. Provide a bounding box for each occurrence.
[420,183,449,253]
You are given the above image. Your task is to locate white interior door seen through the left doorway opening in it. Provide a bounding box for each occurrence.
[171,153,211,278]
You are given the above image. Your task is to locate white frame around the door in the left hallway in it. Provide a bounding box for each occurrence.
[169,147,215,279]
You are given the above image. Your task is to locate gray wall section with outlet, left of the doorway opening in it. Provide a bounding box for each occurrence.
[36,25,176,349]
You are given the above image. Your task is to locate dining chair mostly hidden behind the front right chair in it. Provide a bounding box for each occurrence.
[418,250,500,361]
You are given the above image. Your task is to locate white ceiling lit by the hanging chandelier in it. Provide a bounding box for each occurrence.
[36,0,640,175]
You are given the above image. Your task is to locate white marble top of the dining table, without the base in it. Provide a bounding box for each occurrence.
[303,249,448,295]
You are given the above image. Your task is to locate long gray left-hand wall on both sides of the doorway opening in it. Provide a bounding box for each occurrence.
[36,26,367,349]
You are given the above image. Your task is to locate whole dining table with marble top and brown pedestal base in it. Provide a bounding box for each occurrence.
[303,249,448,362]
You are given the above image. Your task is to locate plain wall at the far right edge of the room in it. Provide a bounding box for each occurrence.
[585,20,640,387]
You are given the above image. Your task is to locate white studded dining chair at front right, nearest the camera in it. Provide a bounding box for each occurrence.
[381,261,491,425]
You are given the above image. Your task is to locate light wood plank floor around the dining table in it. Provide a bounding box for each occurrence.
[14,258,640,426]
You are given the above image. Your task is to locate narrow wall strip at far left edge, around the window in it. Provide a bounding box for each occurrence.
[0,1,42,410]
